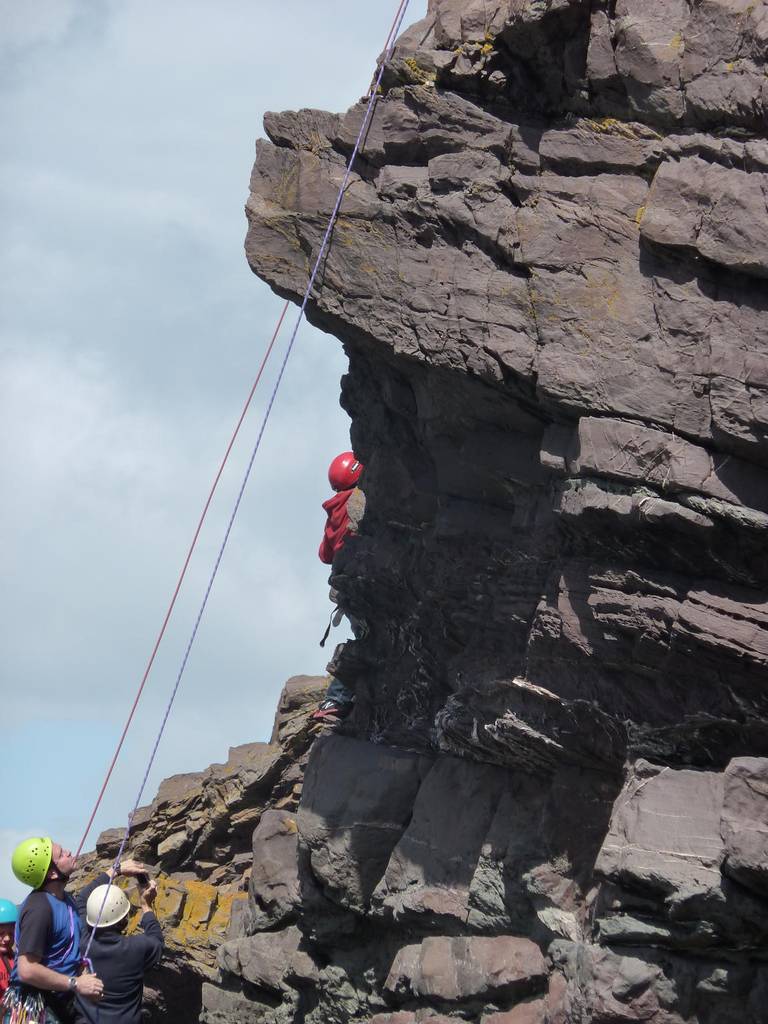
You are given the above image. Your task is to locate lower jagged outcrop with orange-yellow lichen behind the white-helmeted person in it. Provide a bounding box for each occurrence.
[73,676,328,1024]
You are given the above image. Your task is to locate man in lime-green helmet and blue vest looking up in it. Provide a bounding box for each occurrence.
[4,837,103,1024]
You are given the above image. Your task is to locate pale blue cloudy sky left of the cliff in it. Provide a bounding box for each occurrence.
[0,0,426,899]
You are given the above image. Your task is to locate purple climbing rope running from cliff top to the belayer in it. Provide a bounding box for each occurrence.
[82,0,410,961]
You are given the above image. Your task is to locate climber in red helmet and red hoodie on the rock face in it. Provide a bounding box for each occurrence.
[311,452,366,721]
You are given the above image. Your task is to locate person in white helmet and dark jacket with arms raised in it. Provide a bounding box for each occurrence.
[75,861,163,1024]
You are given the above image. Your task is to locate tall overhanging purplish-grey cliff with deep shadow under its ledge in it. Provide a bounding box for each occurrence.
[198,0,768,1024]
